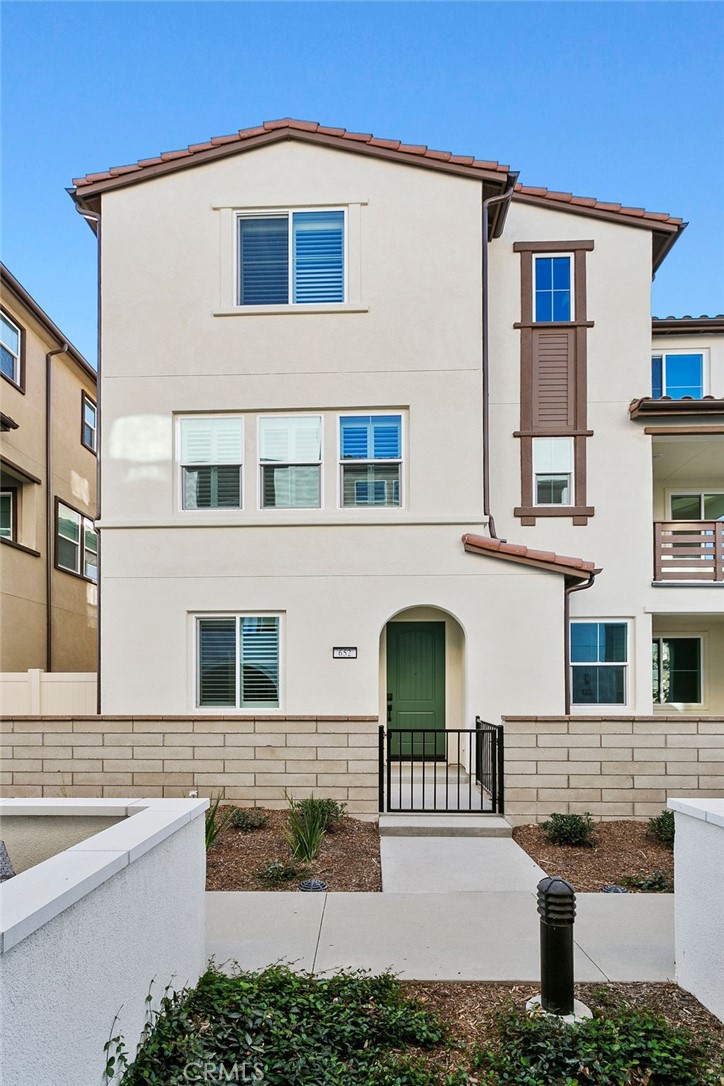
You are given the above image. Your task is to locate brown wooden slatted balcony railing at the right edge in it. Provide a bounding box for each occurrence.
[653,520,724,581]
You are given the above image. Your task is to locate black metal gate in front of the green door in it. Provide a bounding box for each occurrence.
[379,717,505,815]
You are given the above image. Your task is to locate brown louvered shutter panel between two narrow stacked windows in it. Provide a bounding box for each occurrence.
[531,328,576,432]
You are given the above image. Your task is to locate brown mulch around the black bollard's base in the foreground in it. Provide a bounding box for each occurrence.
[402,981,724,1068]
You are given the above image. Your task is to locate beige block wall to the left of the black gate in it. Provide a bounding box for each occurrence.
[0,716,378,815]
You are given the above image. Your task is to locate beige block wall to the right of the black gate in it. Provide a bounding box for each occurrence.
[504,716,724,825]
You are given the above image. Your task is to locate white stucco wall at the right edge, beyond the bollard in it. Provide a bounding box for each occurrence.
[669,799,724,1022]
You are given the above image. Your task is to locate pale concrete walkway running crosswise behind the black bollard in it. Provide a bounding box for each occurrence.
[206,890,674,981]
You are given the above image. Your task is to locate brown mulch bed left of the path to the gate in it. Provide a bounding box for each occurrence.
[206,810,382,892]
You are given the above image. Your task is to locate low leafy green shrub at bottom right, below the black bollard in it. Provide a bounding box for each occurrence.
[474,1007,719,1086]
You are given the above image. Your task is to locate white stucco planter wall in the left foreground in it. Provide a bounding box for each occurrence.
[0,799,208,1086]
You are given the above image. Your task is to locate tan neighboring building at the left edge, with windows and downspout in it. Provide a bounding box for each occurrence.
[0,265,98,672]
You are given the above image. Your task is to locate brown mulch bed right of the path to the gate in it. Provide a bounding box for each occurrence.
[512,819,674,894]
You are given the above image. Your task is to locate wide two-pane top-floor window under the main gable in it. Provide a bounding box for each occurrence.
[238,210,345,305]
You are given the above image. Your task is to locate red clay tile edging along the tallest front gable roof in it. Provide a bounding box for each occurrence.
[73,117,510,189]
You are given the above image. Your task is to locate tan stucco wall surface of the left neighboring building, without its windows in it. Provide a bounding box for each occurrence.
[0,290,97,672]
